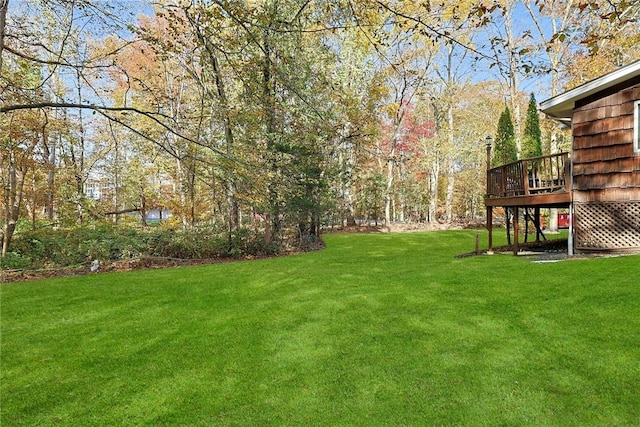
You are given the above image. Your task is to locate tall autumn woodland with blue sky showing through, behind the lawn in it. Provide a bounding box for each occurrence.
[0,0,640,256]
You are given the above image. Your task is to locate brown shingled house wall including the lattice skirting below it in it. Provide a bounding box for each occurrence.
[572,77,640,251]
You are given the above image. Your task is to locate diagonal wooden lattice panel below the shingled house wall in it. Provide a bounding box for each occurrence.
[575,201,640,250]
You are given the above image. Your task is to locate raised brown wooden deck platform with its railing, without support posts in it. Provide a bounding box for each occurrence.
[484,153,571,207]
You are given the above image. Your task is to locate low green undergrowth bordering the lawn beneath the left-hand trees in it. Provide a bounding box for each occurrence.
[0,224,277,269]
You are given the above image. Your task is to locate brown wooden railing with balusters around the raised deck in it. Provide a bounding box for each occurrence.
[487,153,571,197]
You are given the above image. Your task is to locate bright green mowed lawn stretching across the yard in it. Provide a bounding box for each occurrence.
[0,231,640,426]
